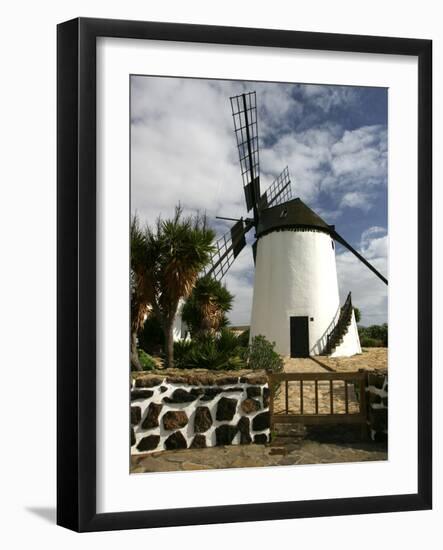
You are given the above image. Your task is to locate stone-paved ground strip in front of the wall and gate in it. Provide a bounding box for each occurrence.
[131,440,387,473]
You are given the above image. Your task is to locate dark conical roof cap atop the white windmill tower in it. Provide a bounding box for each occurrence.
[257,198,334,237]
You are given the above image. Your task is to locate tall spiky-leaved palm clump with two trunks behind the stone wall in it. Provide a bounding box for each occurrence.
[131,205,215,368]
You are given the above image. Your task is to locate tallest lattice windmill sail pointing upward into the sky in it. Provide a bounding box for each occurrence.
[231,92,260,212]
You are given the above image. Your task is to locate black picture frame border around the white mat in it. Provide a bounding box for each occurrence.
[57,18,432,531]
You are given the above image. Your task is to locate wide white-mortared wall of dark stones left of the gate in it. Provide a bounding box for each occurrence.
[130,371,270,454]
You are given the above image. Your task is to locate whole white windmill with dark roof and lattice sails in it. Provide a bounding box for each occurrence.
[206,92,388,357]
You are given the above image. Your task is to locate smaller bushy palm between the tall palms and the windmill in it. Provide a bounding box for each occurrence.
[182,276,234,336]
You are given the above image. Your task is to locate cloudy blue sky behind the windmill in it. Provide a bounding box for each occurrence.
[130,76,388,326]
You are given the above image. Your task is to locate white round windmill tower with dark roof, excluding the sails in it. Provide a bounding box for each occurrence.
[251,199,361,357]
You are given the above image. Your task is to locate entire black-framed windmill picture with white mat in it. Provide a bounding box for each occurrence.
[57,18,432,531]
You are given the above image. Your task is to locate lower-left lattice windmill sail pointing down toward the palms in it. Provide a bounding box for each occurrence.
[205,220,252,281]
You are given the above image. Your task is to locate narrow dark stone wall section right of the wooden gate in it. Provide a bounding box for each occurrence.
[366,371,388,441]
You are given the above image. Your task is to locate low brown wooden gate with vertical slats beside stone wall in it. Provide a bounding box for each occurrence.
[269,370,367,434]
